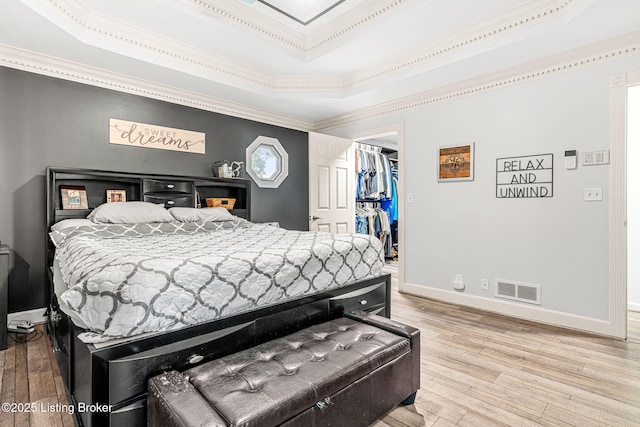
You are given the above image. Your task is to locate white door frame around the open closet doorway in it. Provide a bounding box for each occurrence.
[347,123,406,291]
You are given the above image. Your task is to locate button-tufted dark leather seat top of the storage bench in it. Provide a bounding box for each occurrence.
[183,318,411,426]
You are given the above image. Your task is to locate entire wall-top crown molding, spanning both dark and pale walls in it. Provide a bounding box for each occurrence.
[0,32,640,132]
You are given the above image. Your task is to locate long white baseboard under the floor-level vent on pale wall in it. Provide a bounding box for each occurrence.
[400,283,615,337]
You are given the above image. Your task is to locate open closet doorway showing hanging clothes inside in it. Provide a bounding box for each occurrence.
[349,126,404,278]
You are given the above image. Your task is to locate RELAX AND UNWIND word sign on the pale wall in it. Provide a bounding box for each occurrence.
[496,154,553,199]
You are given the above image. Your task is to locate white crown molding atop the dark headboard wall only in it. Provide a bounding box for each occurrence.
[0,44,313,132]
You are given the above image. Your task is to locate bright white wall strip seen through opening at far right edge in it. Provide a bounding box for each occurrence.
[627,86,640,311]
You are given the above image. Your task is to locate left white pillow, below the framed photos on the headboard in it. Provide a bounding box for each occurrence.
[87,202,174,224]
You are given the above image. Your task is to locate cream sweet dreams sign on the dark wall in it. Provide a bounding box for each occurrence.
[109,119,205,154]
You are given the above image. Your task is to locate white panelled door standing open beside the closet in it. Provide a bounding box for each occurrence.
[309,132,356,233]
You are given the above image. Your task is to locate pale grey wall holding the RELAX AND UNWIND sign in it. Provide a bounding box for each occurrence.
[327,55,640,329]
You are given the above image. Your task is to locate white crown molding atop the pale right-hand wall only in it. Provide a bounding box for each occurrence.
[312,32,640,132]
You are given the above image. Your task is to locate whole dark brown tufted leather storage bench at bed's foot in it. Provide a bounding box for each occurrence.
[147,312,420,427]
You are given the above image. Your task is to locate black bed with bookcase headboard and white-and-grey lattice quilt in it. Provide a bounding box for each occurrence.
[47,168,390,426]
